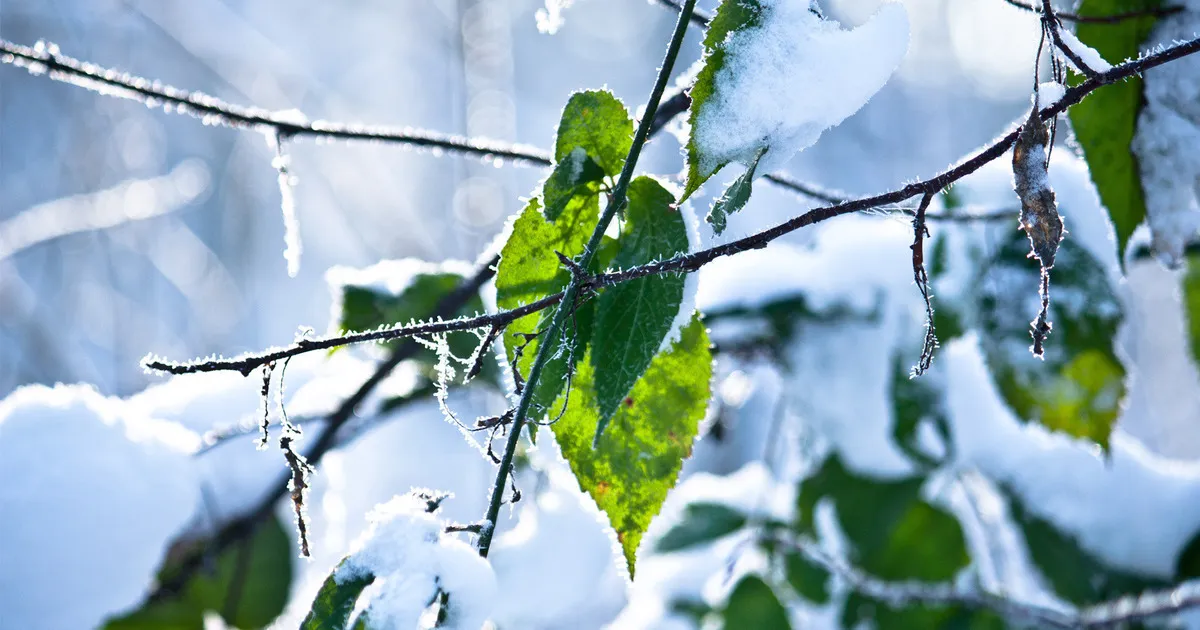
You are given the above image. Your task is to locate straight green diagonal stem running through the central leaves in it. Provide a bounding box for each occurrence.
[479,0,696,558]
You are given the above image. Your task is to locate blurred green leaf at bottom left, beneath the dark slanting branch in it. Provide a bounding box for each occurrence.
[104,518,293,630]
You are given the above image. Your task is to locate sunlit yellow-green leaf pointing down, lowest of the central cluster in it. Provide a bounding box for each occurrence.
[551,317,713,575]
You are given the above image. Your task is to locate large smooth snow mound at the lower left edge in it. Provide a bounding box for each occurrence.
[0,385,199,630]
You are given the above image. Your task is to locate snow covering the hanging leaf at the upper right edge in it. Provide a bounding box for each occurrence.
[1133,11,1200,266]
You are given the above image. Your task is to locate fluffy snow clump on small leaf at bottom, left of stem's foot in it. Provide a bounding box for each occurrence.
[335,494,497,630]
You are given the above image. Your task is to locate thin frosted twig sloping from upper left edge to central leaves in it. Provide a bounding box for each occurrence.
[0,40,553,166]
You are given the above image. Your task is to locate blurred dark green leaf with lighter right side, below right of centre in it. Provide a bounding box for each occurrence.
[797,456,971,582]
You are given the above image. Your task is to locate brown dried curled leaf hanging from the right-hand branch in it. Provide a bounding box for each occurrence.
[1013,108,1063,269]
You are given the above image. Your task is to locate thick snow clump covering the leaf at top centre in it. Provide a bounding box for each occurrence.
[692,0,908,173]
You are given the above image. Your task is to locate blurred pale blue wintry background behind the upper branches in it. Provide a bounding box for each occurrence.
[0,0,1038,397]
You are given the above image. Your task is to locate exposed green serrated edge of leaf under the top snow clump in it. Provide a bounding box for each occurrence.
[680,0,763,202]
